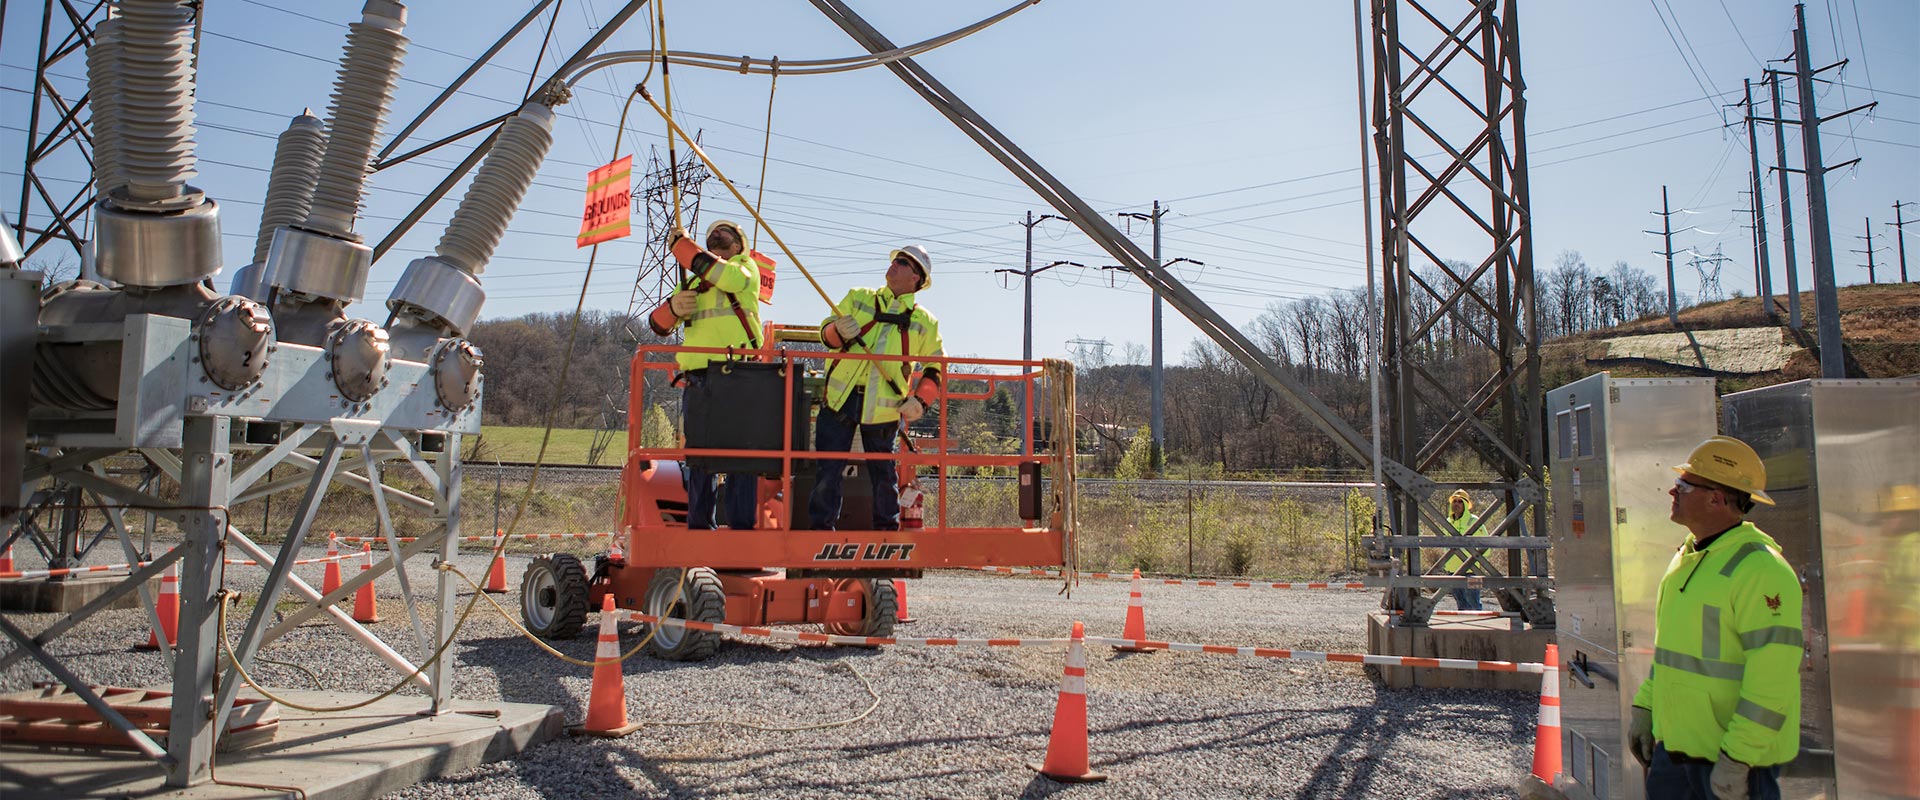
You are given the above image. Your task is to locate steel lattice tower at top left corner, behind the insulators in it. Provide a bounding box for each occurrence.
[12,0,110,259]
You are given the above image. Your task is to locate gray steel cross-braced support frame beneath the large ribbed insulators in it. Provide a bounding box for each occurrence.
[0,315,480,787]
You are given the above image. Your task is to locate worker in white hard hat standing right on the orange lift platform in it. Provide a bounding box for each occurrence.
[806,244,947,531]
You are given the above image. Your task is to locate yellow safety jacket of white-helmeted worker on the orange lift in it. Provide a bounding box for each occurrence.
[820,288,947,424]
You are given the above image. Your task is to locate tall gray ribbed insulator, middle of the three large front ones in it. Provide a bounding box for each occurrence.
[303,0,407,238]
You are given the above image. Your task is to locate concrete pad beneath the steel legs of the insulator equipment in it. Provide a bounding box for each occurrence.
[0,689,564,800]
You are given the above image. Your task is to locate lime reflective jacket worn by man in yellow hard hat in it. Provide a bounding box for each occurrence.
[1634,522,1803,767]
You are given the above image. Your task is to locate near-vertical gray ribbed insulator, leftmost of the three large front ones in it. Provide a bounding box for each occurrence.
[119,0,198,205]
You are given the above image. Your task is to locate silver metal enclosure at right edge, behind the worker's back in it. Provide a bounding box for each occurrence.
[1722,378,1920,798]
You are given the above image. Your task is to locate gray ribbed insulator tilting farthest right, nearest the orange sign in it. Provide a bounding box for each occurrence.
[434,100,553,276]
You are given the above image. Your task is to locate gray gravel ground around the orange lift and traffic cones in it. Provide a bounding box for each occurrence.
[0,549,1538,798]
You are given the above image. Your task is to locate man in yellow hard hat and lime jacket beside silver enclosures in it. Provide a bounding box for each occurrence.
[1628,435,1803,800]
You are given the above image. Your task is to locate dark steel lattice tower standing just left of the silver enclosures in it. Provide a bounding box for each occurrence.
[1373,0,1553,624]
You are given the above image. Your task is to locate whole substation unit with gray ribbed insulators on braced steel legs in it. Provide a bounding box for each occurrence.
[0,0,559,787]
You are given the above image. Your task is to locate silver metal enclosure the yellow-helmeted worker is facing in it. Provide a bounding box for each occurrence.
[1548,372,1715,800]
